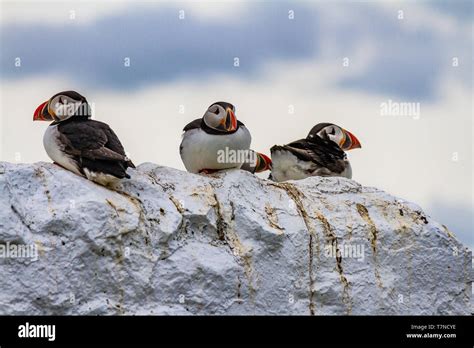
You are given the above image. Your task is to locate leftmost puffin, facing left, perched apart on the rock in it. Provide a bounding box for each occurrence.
[33,91,135,186]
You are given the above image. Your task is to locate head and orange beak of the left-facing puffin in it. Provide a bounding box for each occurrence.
[33,91,91,122]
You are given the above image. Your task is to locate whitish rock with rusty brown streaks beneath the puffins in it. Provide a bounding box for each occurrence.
[0,162,472,315]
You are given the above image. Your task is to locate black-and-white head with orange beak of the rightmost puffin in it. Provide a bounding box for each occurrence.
[306,123,361,151]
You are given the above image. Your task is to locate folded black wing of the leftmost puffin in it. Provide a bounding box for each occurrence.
[58,120,135,178]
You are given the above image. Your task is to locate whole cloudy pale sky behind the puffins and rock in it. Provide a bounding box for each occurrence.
[0,0,474,248]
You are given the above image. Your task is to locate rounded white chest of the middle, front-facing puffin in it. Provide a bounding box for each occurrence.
[181,126,251,173]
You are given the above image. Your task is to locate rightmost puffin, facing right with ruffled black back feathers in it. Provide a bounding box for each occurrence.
[270,123,361,182]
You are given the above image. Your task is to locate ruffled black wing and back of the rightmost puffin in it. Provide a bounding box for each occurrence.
[270,137,346,173]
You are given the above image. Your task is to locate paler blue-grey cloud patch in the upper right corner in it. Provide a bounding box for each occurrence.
[328,2,472,101]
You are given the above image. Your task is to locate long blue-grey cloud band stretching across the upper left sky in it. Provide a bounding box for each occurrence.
[1,4,317,89]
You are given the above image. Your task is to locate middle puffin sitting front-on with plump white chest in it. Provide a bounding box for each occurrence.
[179,101,252,174]
